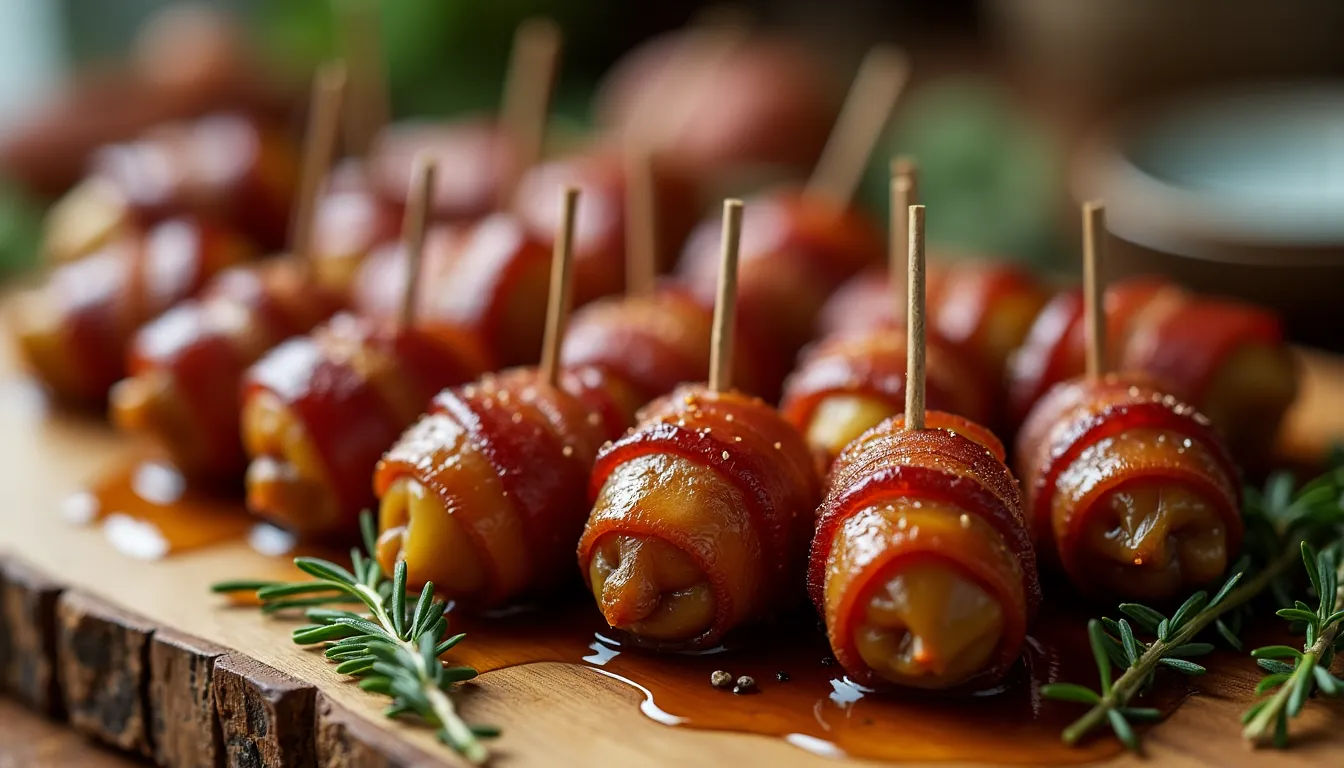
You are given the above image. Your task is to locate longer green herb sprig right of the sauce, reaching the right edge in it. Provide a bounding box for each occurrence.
[1042,463,1344,752]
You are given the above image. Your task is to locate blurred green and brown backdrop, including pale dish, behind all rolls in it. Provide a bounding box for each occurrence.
[0,0,1344,347]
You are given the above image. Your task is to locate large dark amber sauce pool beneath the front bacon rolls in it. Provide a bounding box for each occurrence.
[438,604,1185,765]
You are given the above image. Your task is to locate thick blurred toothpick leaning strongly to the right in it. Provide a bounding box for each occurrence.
[806,46,910,207]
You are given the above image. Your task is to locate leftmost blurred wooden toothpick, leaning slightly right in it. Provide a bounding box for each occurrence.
[289,62,345,265]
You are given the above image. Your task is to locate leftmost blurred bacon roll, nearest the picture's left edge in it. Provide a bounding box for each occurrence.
[12,219,254,404]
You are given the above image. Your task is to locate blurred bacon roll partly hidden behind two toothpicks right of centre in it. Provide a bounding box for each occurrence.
[818,258,1050,390]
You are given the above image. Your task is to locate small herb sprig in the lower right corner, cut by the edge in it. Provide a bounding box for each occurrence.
[1242,542,1344,749]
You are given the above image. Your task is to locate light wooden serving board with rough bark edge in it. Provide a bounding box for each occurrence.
[0,334,1344,768]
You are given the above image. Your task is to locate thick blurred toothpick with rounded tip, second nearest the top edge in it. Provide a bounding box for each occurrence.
[497,17,560,208]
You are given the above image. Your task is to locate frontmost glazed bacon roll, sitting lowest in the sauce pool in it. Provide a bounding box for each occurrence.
[808,412,1040,689]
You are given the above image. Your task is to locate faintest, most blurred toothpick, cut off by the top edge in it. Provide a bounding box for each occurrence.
[333,0,391,157]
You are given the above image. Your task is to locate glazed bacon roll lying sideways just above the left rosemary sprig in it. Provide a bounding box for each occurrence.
[374,367,642,608]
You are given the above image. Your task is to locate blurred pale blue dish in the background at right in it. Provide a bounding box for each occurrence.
[1074,83,1344,350]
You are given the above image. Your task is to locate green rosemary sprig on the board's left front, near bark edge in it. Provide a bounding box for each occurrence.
[211,512,499,764]
